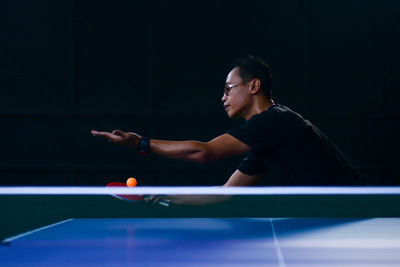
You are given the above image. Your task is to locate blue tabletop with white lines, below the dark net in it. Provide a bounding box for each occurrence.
[0,218,400,267]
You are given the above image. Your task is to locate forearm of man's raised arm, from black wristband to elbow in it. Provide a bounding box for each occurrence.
[150,139,209,163]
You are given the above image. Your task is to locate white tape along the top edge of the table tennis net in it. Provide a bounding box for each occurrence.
[0,186,400,196]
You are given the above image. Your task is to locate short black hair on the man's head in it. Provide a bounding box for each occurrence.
[233,55,272,98]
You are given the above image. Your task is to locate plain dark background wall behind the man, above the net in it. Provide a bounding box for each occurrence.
[0,0,400,185]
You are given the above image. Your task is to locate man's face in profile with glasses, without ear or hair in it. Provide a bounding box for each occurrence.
[222,68,251,118]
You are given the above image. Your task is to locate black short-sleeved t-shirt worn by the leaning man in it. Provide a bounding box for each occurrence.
[228,105,360,185]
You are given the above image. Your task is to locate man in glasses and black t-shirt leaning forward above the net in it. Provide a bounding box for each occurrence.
[92,56,358,186]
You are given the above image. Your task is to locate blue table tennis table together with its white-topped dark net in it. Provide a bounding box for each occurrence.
[0,187,400,267]
